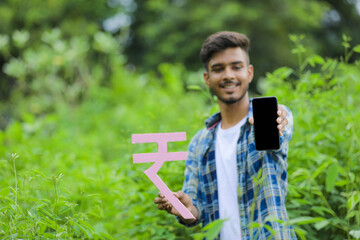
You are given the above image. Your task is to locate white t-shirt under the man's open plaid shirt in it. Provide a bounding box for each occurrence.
[215,117,246,240]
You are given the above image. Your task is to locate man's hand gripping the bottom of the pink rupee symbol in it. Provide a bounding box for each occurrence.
[154,191,199,224]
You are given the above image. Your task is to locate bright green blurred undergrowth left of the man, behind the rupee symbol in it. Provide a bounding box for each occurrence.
[0,37,211,239]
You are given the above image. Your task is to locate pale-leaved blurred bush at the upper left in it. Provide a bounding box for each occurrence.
[3,28,124,125]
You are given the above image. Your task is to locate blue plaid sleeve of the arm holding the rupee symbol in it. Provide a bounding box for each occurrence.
[176,133,203,227]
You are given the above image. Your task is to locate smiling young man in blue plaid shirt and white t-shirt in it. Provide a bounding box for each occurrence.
[154,32,296,240]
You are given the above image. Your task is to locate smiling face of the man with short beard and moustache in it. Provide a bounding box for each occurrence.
[204,47,254,104]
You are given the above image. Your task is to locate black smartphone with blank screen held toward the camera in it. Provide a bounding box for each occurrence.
[252,97,280,151]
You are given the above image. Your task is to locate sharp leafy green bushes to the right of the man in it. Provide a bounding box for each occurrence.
[262,35,360,239]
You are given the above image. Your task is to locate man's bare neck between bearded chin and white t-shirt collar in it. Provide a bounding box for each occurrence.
[218,93,250,129]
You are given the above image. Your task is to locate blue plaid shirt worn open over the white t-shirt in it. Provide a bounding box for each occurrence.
[178,99,296,240]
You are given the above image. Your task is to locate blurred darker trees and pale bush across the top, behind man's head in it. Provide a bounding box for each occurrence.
[0,0,360,128]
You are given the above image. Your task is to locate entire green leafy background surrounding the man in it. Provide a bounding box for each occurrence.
[0,0,360,239]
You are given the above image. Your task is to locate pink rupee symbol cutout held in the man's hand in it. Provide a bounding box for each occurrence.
[132,132,195,219]
